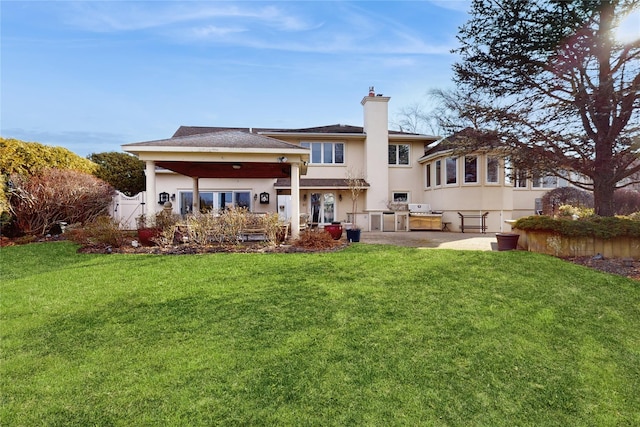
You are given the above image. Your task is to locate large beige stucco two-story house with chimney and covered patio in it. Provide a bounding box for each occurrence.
[122,88,558,235]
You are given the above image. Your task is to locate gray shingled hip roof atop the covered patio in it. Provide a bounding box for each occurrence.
[123,130,308,151]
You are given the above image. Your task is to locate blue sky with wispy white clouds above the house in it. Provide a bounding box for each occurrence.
[0,0,469,156]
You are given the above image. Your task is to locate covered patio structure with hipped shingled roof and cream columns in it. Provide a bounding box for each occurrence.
[122,131,309,237]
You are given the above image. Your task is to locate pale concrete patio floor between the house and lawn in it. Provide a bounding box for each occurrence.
[360,231,498,251]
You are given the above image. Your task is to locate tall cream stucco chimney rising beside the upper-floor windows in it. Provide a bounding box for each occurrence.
[361,86,391,211]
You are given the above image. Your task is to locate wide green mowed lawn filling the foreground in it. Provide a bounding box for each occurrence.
[0,242,640,426]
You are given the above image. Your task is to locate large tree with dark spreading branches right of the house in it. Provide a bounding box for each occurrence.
[454,0,640,216]
